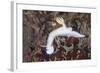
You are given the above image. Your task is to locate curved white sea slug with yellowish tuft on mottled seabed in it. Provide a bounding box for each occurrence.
[46,17,85,55]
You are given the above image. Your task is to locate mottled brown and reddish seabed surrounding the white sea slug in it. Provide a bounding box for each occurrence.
[23,10,91,62]
